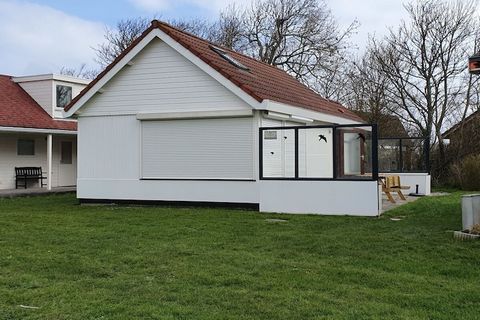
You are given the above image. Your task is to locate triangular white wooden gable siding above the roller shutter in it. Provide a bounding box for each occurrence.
[82,39,250,115]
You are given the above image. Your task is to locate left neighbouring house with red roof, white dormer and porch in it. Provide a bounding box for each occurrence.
[0,74,88,189]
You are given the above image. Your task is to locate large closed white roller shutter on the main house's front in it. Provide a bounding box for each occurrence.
[142,117,254,179]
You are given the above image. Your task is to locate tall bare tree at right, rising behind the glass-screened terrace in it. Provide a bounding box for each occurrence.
[370,0,475,165]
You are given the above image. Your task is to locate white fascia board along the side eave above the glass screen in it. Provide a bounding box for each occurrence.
[261,100,361,124]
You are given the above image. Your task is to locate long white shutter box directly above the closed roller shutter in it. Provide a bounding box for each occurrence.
[137,110,253,120]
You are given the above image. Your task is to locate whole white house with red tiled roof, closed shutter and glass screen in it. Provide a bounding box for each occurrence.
[65,21,412,216]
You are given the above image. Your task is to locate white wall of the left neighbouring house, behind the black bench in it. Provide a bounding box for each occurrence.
[0,133,77,189]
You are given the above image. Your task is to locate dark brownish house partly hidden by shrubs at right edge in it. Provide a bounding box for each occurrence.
[442,110,480,160]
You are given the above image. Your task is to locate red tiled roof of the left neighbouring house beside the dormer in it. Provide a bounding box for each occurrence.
[0,75,77,131]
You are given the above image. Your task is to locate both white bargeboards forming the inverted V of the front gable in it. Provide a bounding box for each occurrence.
[65,29,260,117]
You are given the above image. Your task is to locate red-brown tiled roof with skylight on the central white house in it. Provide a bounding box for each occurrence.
[65,20,363,122]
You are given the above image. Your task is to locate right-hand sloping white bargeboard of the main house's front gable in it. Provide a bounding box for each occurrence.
[153,29,261,109]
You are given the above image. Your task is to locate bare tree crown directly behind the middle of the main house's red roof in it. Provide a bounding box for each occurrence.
[243,0,357,86]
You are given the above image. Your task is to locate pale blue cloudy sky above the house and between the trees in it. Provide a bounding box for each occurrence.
[0,0,404,76]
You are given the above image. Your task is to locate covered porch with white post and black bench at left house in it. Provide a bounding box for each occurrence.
[0,127,77,192]
